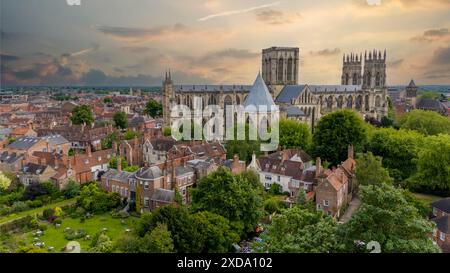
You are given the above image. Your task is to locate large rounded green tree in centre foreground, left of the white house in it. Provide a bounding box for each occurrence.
[191,167,263,233]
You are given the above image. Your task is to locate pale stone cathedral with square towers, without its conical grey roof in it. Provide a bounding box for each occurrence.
[162,47,388,130]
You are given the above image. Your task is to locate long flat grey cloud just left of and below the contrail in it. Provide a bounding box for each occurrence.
[96,23,189,40]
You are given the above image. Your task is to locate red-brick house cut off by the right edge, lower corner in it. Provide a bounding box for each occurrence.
[431,197,450,253]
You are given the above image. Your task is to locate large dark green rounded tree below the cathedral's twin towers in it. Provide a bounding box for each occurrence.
[313,110,367,166]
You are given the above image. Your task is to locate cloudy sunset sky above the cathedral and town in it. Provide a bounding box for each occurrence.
[0,0,450,86]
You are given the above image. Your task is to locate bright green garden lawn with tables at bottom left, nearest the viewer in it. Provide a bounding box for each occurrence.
[26,213,137,252]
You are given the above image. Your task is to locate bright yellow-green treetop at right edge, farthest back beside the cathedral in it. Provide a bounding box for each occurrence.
[399,110,450,135]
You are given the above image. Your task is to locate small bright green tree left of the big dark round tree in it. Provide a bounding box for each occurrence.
[280,119,312,149]
